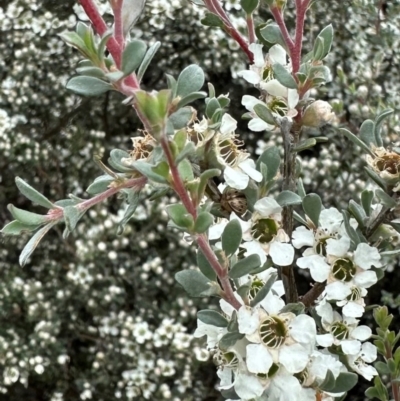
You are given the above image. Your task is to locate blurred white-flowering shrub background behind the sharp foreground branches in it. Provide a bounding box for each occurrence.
[0,0,400,401]
